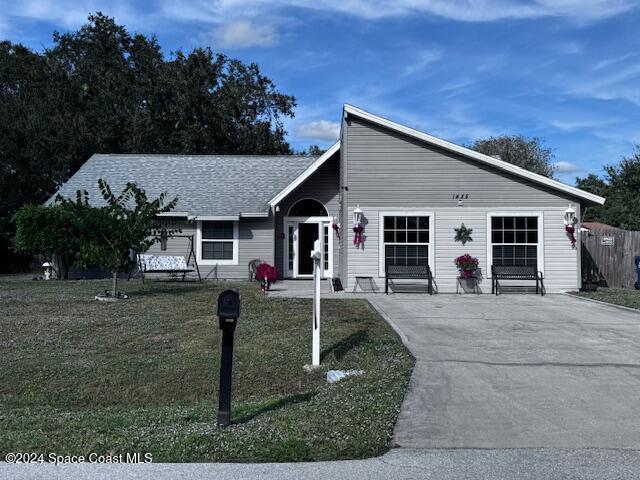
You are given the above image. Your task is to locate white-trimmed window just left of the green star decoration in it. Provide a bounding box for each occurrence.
[382,215,430,270]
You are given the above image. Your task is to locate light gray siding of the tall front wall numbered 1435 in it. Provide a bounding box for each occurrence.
[342,118,579,292]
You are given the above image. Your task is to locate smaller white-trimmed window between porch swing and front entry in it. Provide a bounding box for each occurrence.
[199,220,238,264]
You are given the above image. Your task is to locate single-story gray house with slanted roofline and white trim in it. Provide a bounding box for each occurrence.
[51,105,605,292]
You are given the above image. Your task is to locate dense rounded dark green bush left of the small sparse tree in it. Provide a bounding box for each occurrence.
[15,197,90,280]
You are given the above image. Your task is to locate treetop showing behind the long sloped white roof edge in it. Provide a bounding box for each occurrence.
[469,135,555,178]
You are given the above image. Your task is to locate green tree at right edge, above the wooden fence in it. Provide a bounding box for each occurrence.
[576,145,640,230]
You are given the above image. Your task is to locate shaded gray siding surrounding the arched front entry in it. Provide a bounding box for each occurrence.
[275,150,340,276]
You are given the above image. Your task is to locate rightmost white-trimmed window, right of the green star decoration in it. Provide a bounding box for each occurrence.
[491,216,540,267]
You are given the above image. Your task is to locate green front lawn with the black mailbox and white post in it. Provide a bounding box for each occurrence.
[0,280,413,461]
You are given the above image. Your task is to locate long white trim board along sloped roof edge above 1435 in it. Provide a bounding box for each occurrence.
[344,103,606,205]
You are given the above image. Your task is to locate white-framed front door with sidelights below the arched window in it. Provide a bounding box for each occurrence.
[284,217,333,278]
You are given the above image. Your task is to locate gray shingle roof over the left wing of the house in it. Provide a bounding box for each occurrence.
[47,154,316,216]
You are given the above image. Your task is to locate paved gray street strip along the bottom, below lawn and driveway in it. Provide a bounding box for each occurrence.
[0,449,640,480]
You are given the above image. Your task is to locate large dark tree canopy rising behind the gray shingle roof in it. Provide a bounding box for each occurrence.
[0,13,295,268]
